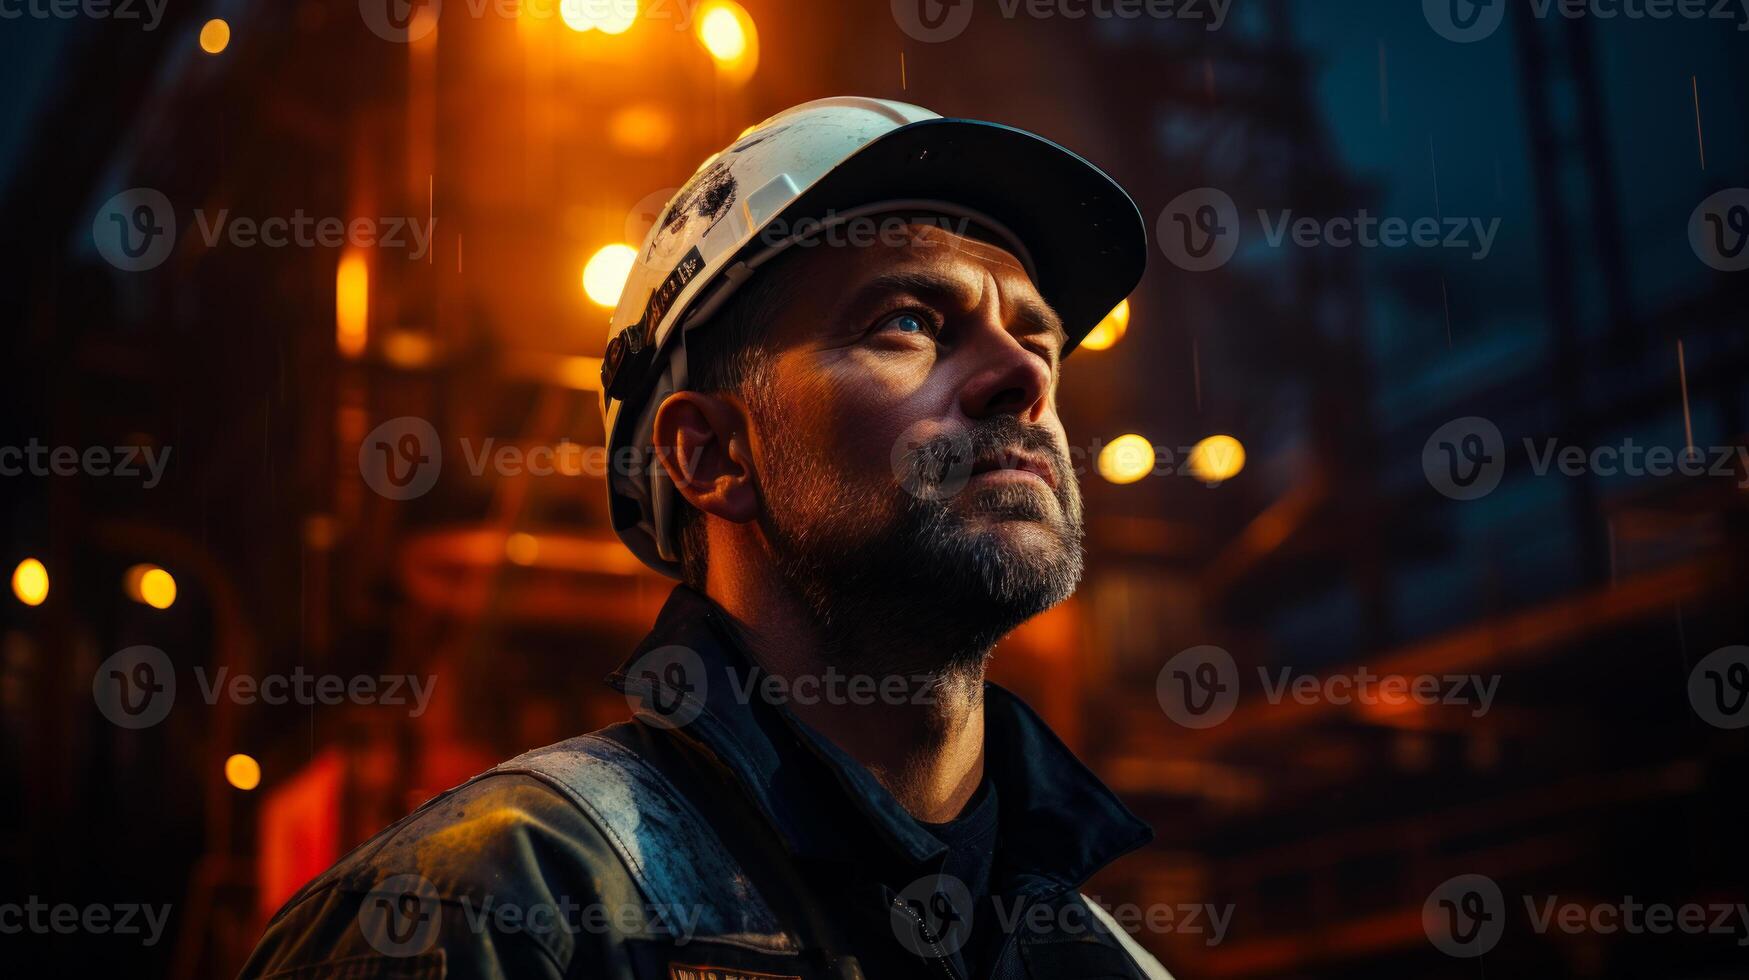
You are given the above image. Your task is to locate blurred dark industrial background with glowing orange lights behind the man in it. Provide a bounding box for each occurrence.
[0,0,1749,980]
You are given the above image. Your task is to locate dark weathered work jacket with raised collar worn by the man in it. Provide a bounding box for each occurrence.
[229,586,1167,980]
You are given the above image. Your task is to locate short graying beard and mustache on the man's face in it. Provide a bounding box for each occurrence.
[761,409,1083,679]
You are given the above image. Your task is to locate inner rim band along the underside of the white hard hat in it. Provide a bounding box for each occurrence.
[638,198,1039,562]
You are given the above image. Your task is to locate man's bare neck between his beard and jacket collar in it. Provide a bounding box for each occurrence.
[707,564,985,823]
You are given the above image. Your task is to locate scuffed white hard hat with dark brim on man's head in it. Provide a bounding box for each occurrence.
[602,96,1147,578]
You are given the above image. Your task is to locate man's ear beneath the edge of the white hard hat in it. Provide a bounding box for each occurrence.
[652,392,759,523]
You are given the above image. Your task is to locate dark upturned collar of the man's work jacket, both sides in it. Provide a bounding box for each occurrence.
[607,585,1153,894]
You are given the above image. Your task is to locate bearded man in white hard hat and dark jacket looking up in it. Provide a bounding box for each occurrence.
[245,98,1165,980]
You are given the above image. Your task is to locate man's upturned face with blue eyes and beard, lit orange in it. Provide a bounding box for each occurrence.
[750,224,1081,665]
